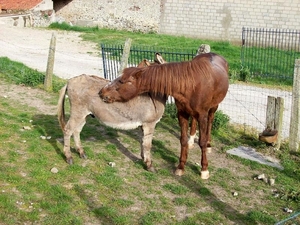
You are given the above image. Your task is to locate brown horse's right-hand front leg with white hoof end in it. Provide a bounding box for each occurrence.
[198,112,209,179]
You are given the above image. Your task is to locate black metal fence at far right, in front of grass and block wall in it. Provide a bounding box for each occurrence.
[241,28,300,80]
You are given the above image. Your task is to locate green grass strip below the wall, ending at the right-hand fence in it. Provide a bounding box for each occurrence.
[49,23,241,70]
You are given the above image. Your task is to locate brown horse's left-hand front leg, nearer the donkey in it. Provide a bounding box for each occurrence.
[175,111,189,176]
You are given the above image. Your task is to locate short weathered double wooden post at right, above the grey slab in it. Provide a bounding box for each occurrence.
[266,96,284,149]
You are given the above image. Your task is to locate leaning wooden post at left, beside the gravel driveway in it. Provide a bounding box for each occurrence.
[44,33,56,91]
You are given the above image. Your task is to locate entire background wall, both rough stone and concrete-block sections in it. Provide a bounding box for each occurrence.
[56,0,300,41]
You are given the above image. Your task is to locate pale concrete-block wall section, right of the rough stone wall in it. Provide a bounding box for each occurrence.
[159,0,300,40]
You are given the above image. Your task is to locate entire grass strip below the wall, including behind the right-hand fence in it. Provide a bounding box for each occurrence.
[49,23,299,90]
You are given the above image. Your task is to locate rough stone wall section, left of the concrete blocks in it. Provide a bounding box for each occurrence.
[56,0,160,32]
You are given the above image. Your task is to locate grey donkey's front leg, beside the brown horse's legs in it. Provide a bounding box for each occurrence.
[141,123,156,172]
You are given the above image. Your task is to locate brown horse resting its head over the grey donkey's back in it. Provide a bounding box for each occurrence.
[99,53,229,179]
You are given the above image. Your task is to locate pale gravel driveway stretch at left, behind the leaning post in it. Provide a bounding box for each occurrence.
[0,25,103,78]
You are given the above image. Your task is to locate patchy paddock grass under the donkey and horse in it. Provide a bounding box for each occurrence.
[0,78,300,225]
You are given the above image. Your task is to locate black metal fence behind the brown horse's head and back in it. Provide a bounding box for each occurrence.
[101,44,198,80]
